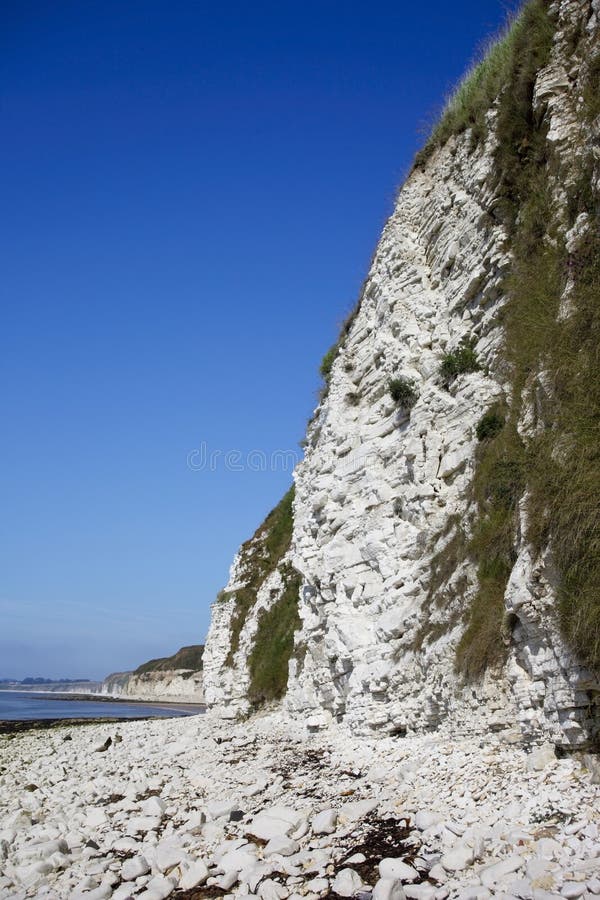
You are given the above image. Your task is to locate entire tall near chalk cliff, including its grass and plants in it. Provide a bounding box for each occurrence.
[204,0,600,747]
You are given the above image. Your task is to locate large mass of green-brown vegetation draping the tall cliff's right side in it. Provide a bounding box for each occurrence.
[416,0,600,678]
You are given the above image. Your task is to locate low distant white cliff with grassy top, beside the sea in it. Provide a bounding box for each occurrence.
[101,644,204,703]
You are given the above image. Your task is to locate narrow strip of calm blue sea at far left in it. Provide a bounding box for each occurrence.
[0,691,200,721]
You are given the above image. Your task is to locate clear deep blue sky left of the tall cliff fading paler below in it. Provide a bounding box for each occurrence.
[0,0,508,677]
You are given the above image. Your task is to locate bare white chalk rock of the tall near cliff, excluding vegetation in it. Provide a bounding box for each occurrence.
[204,0,600,746]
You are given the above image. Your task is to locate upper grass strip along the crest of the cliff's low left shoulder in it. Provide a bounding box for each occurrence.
[219,486,294,666]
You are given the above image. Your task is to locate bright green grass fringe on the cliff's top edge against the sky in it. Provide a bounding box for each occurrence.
[414,0,548,168]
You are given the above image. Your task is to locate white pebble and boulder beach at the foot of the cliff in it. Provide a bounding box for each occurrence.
[0,714,600,900]
